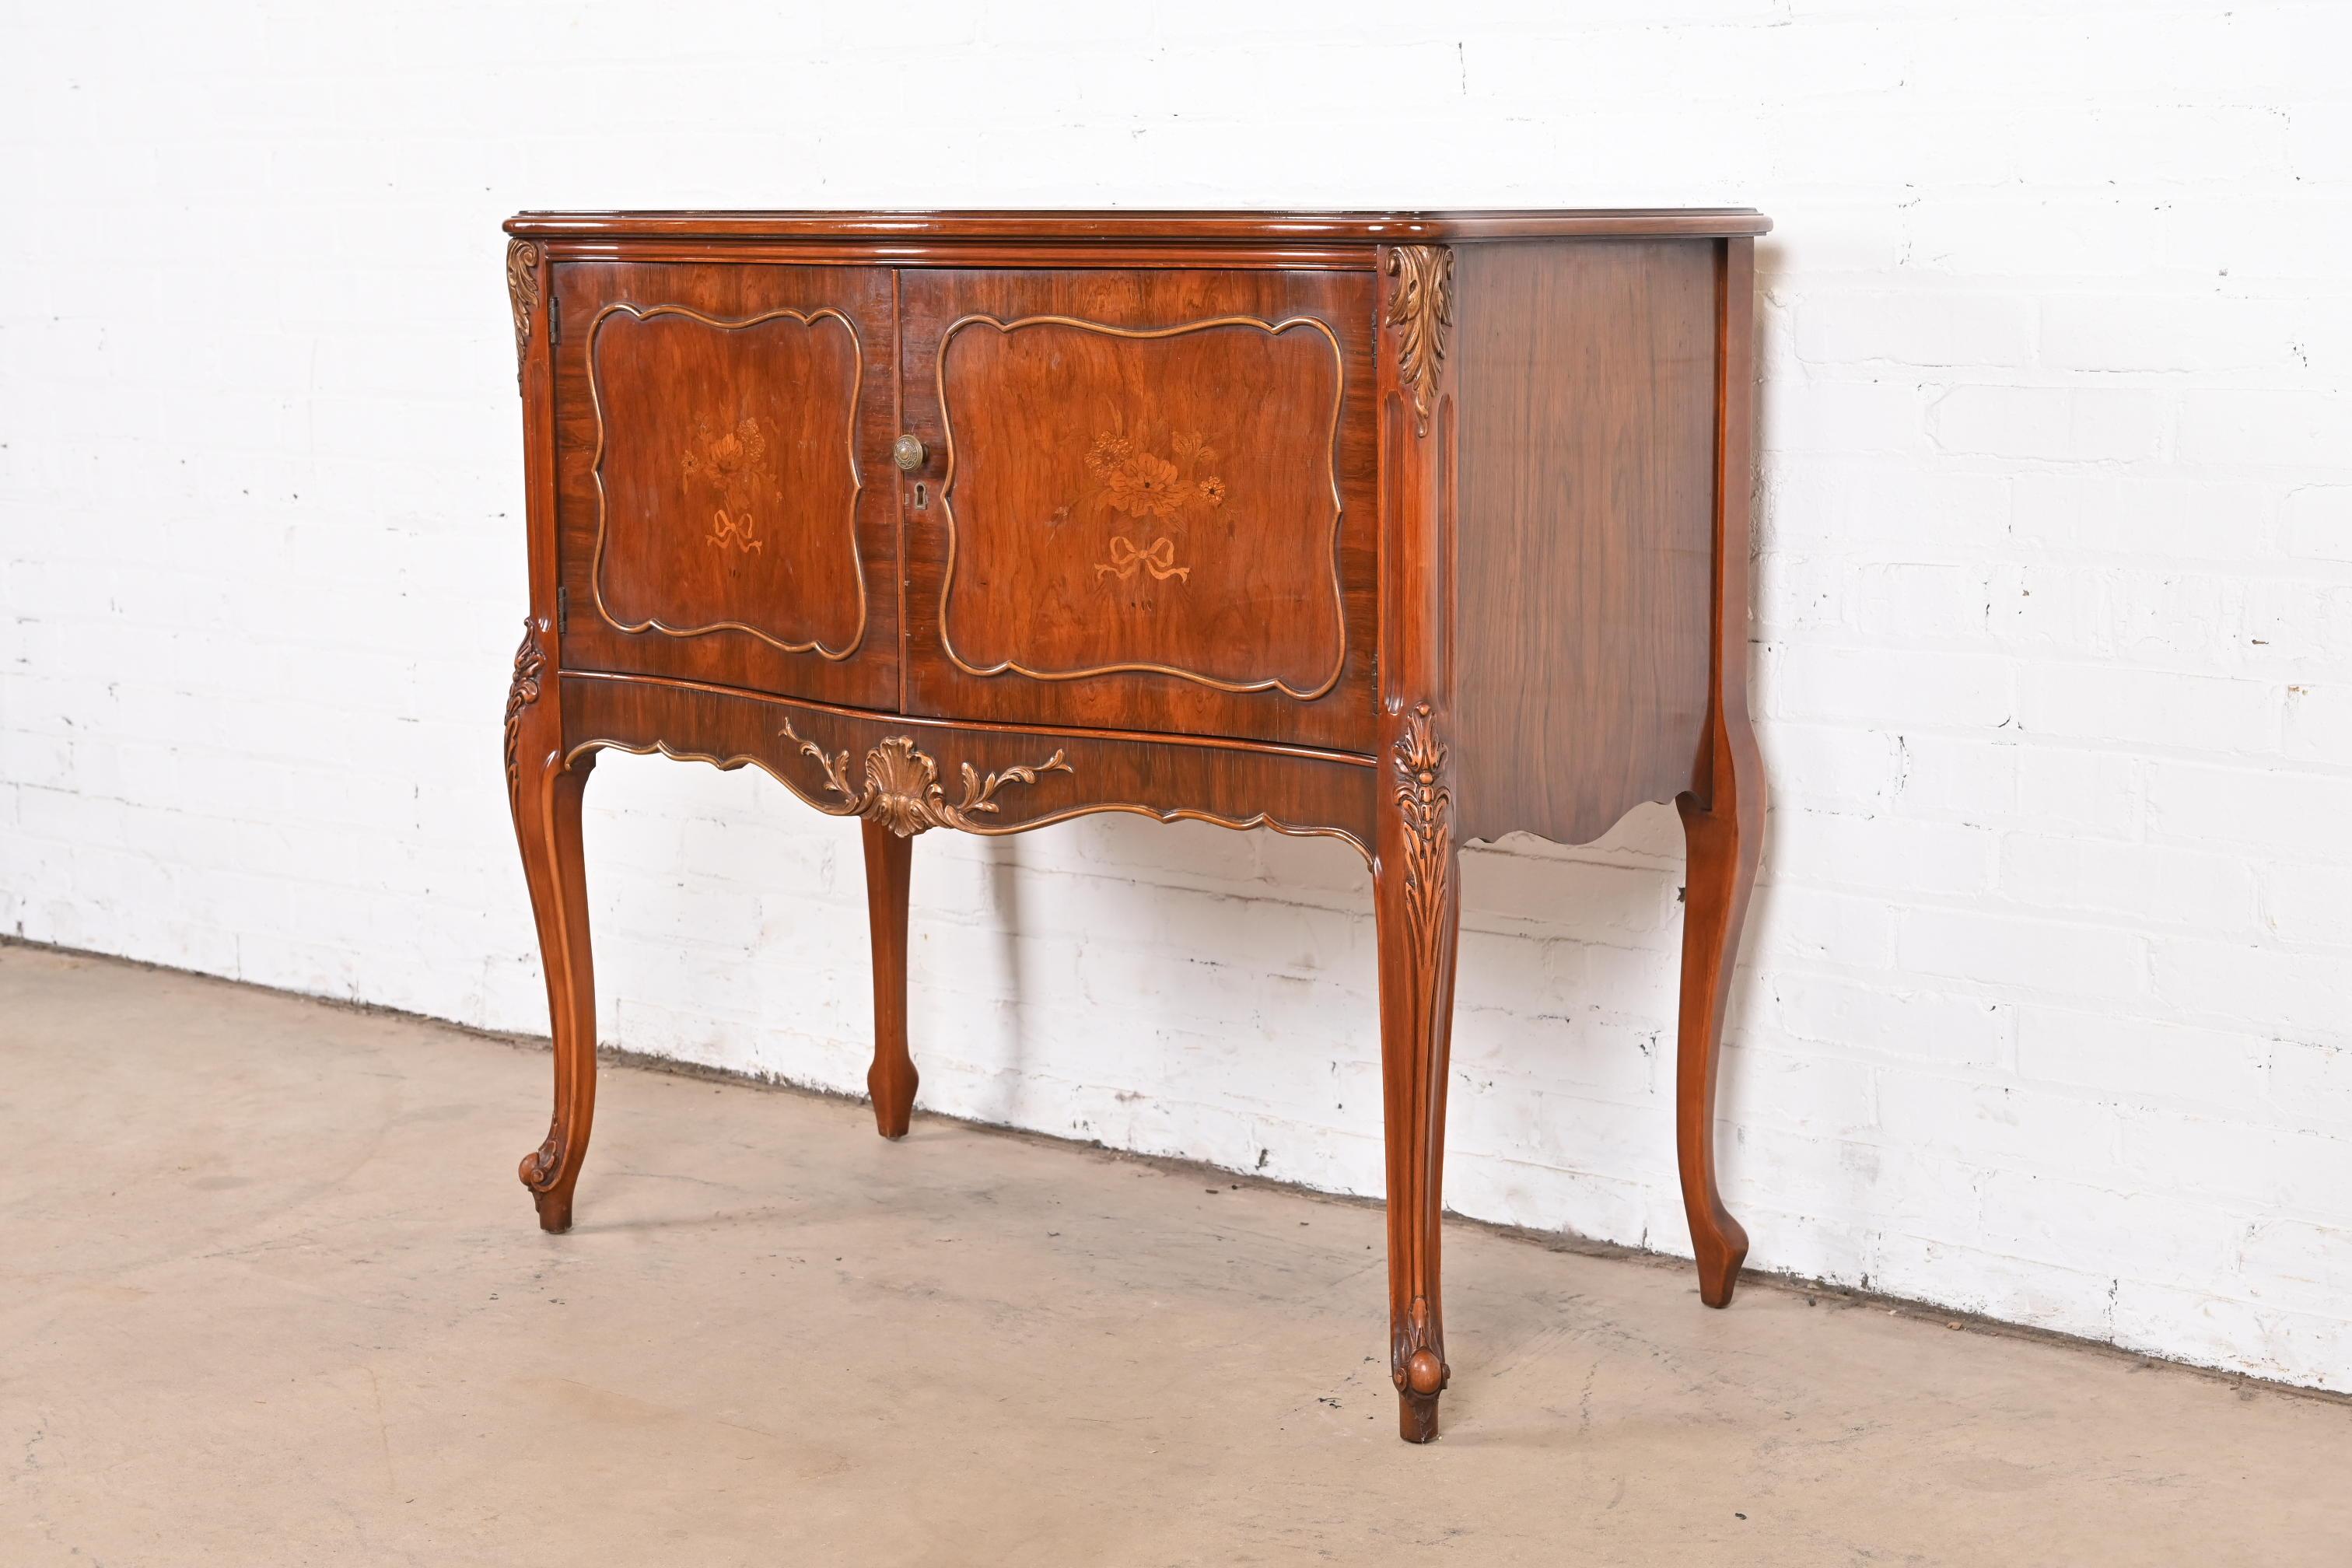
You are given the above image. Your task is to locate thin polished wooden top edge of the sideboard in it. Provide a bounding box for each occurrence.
[506,207,1771,244]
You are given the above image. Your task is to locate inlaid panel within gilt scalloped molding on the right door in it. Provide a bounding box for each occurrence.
[934,315,1348,701]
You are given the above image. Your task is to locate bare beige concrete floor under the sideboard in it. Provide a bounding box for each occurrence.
[0,947,2352,1568]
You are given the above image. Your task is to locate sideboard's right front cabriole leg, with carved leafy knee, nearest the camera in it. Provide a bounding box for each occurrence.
[1374,703,1461,1444]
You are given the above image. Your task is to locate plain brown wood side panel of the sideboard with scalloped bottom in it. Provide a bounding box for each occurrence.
[1454,240,1717,844]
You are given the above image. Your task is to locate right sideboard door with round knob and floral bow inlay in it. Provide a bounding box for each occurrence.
[901,271,1376,750]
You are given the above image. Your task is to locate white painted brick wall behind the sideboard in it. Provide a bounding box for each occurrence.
[0,0,2352,1389]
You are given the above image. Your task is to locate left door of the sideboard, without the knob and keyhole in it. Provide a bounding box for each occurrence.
[555,261,898,708]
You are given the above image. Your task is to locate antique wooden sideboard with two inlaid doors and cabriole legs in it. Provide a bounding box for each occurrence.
[506,209,1769,1441]
